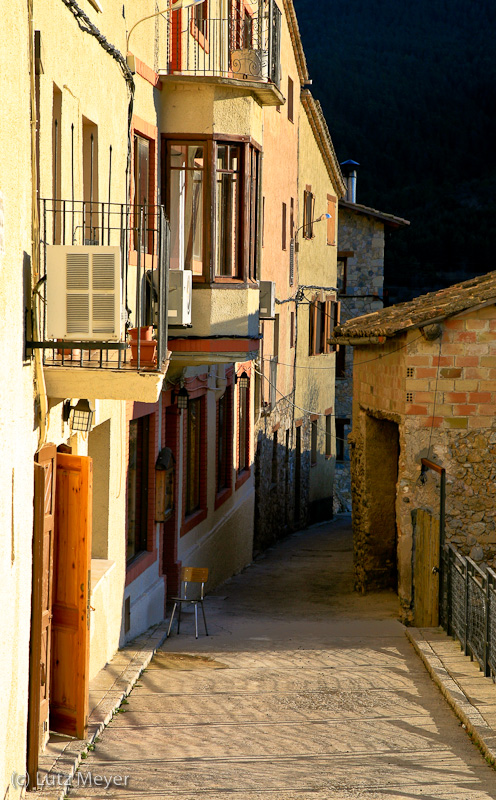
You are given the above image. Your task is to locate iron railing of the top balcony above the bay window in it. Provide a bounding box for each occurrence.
[166,0,282,88]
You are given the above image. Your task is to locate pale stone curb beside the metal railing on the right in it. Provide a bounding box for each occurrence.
[405,628,496,767]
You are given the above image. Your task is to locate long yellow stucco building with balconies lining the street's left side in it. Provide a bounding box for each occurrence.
[0,0,342,797]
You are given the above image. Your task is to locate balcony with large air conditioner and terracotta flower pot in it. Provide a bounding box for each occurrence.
[30,200,170,403]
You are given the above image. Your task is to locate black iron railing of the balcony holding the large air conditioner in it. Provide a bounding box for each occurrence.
[31,199,170,372]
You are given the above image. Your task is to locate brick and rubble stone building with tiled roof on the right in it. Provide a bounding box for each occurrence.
[335,272,496,621]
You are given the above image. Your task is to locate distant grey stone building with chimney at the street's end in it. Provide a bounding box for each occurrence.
[334,197,409,513]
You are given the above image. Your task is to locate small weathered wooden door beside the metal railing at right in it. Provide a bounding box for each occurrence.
[414,508,439,628]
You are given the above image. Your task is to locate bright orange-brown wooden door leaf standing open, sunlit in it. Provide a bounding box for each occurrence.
[50,453,92,739]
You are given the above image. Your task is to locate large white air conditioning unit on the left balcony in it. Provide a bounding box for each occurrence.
[46,245,124,342]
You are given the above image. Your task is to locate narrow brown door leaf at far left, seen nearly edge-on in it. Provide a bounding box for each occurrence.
[28,445,57,786]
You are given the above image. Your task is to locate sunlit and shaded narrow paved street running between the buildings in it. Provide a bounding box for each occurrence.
[70,518,496,800]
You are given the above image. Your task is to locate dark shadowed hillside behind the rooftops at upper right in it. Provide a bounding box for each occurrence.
[295,0,496,302]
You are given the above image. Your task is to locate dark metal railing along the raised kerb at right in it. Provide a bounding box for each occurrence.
[440,544,496,680]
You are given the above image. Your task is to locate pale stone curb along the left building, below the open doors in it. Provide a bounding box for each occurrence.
[32,621,167,800]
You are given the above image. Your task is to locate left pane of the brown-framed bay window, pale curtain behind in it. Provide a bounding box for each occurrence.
[169,144,204,275]
